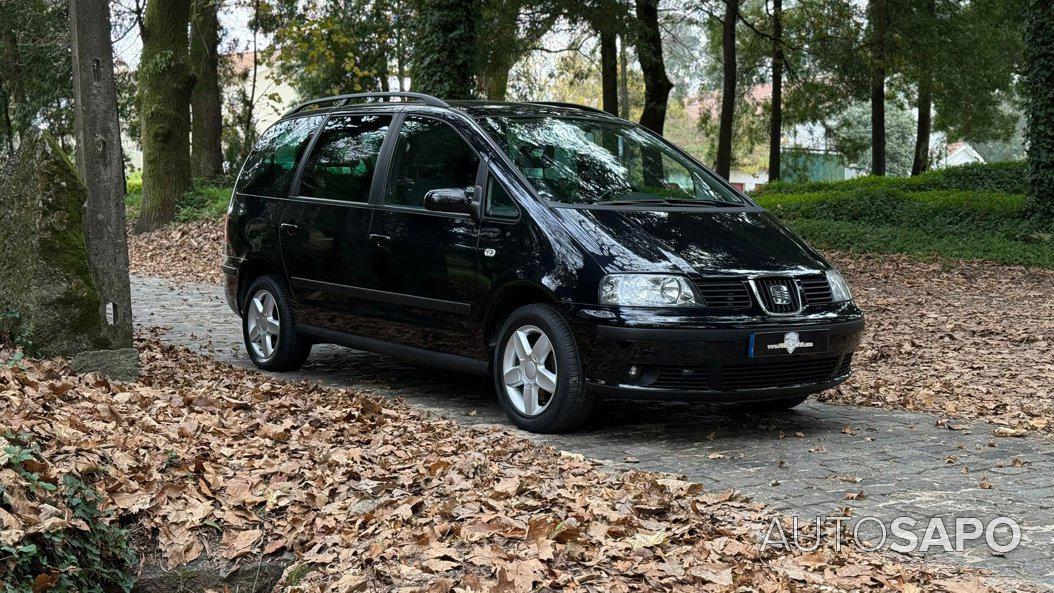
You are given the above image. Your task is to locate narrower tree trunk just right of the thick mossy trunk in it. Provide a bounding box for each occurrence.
[191,0,223,177]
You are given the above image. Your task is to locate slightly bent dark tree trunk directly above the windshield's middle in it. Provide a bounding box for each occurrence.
[635,0,674,134]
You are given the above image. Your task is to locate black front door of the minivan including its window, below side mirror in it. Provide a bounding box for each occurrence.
[369,115,480,357]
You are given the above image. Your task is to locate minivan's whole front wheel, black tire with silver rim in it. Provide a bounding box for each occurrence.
[491,304,593,433]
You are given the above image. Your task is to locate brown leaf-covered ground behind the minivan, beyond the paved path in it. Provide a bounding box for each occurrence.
[130,221,1054,434]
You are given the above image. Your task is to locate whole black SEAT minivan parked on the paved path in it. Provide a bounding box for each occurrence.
[223,93,863,432]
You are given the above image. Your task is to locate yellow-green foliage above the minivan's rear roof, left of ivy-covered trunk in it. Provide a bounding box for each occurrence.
[261,0,396,97]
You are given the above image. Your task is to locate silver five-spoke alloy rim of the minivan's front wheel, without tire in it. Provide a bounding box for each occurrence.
[502,325,557,416]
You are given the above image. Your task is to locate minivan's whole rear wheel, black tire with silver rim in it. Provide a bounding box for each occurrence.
[241,274,311,373]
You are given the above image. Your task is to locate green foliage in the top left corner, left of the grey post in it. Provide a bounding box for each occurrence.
[0,0,74,156]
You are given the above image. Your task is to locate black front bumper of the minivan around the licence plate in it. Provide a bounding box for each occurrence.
[572,303,864,402]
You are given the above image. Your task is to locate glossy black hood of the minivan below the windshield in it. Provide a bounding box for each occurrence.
[555,207,829,274]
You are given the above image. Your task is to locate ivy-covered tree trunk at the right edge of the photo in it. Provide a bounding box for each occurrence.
[1024,0,1054,221]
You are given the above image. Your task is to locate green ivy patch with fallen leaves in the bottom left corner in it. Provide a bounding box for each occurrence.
[0,433,136,593]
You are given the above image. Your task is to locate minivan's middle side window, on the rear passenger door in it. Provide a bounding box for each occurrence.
[299,115,392,202]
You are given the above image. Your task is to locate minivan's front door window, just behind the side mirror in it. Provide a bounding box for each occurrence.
[385,116,480,209]
